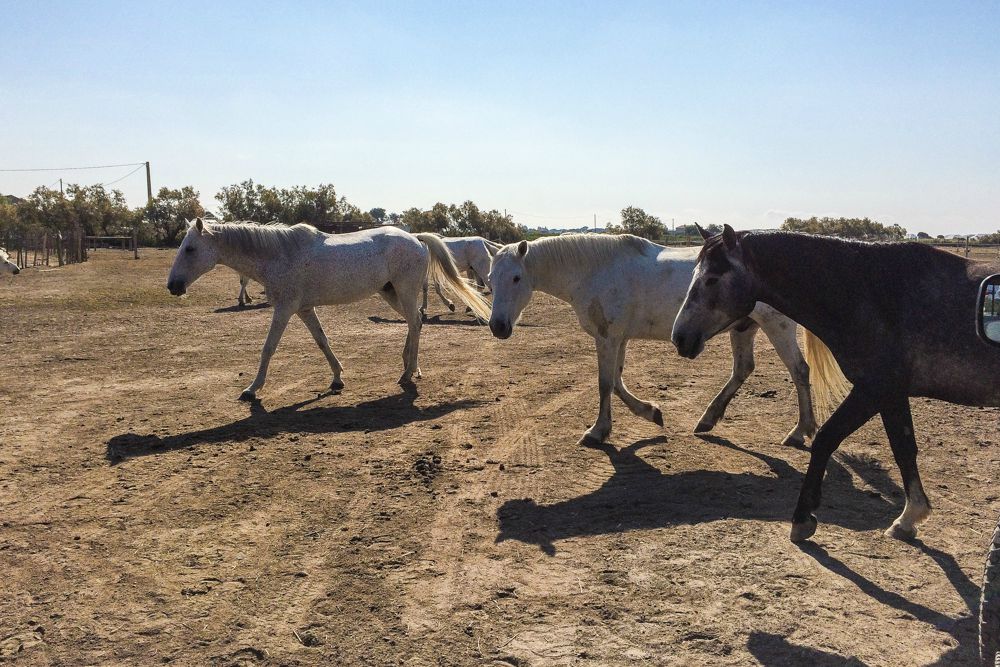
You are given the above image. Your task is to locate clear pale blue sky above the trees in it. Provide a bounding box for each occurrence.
[0,0,1000,234]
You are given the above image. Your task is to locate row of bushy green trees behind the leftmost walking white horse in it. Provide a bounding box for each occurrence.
[0,180,527,246]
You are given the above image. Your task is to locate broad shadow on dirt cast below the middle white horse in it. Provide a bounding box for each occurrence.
[496,435,902,556]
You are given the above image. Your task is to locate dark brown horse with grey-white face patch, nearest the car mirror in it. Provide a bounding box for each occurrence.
[672,225,1000,541]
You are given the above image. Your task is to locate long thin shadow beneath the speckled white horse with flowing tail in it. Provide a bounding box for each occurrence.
[106,387,483,465]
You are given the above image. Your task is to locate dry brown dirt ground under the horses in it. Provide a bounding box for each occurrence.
[0,250,1000,666]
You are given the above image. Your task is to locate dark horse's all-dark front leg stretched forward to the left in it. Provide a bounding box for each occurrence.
[791,386,881,542]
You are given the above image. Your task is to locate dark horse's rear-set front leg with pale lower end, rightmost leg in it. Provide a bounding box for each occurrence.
[882,397,931,540]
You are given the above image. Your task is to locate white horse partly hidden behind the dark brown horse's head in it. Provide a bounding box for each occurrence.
[490,234,816,446]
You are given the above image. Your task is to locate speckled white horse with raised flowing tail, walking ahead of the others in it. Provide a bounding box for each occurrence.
[167,218,489,400]
